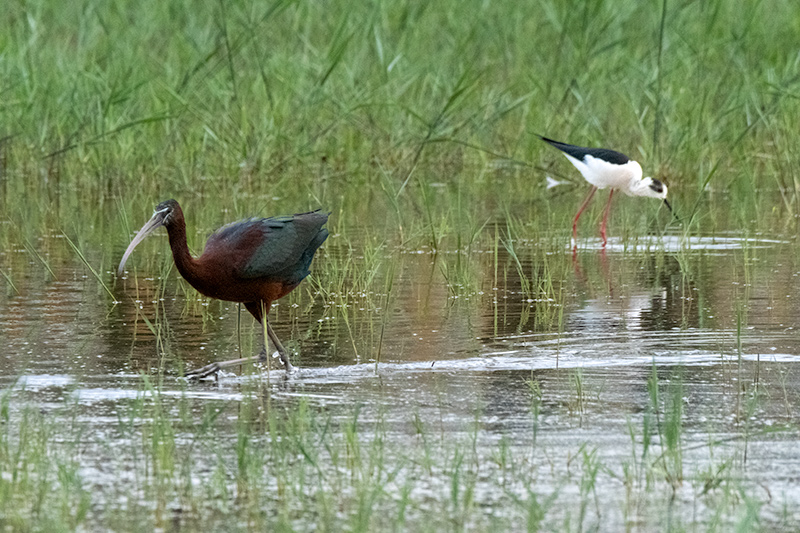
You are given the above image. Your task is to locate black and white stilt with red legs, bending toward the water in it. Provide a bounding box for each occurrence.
[539,135,672,247]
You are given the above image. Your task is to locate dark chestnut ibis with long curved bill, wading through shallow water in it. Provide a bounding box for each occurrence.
[118,200,329,378]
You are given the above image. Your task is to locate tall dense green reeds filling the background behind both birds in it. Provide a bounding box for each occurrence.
[0,0,800,239]
